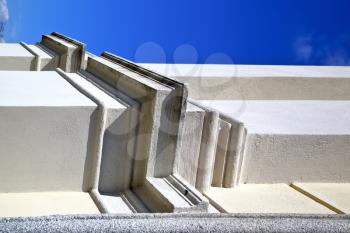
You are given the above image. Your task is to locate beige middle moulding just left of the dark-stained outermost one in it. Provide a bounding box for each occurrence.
[86,57,177,189]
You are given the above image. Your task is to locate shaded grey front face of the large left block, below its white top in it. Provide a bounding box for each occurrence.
[0,106,95,192]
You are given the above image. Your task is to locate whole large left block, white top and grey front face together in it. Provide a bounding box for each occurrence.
[0,71,97,192]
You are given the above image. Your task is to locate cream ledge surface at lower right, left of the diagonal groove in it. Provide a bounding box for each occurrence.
[205,184,335,214]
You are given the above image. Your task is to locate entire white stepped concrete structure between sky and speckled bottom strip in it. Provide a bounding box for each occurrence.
[0,33,350,216]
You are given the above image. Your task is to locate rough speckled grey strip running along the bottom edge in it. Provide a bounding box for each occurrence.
[0,214,350,233]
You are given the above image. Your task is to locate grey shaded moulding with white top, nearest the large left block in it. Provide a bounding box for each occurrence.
[59,70,136,194]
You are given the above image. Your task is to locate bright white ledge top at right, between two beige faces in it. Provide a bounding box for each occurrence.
[200,100,350,135]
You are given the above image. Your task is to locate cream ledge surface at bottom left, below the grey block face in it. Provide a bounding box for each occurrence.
[0,192,100,218]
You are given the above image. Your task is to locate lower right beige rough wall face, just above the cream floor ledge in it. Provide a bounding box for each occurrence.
[240,134,350,183]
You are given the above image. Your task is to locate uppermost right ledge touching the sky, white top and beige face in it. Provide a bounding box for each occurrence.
[141,64,350,100]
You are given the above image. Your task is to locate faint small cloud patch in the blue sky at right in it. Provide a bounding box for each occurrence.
[294,35,314,62]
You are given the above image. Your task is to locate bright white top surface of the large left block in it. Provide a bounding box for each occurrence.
[0,71,96,107]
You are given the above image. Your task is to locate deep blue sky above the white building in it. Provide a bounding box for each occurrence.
[0,0,350,65]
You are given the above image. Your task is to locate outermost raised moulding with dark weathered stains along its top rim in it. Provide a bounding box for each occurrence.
[101,52,188,177]
